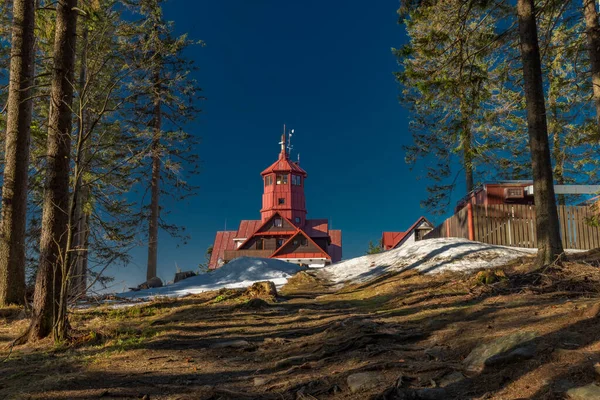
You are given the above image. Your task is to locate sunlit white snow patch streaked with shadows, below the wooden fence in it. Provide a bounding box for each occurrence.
[322,238,537,283]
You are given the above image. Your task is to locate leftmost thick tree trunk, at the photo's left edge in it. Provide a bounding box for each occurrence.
[0,0,35,305]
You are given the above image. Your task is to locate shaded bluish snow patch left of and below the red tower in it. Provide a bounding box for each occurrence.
[117,257,304,299]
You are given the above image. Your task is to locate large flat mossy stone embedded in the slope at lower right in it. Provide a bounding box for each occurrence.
[463,331,538,373]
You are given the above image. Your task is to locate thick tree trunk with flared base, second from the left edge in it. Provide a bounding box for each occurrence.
[28,0,77,341]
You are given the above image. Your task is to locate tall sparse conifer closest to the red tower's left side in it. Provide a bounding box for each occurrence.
[123,0,201,279]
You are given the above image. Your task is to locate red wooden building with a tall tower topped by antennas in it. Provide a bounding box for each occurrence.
[209,135,342,269]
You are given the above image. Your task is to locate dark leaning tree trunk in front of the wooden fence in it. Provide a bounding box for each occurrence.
[517,0,563,267]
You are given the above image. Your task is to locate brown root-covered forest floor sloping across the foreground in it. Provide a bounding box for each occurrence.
[0,253,600,400]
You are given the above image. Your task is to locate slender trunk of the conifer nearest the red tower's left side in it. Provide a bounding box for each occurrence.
[146,72,161,279]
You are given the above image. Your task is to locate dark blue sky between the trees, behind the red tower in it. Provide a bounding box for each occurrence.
[109,0,464,290]
